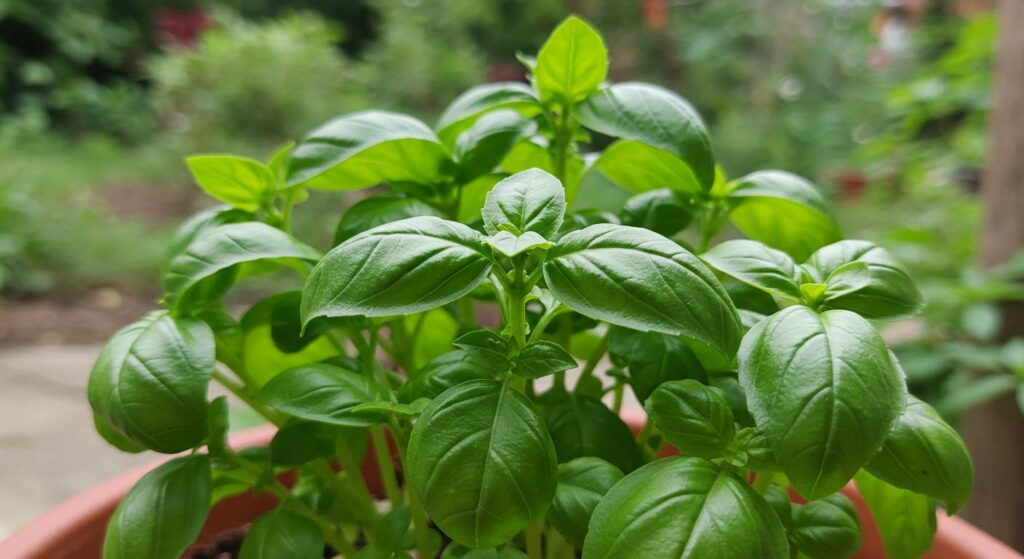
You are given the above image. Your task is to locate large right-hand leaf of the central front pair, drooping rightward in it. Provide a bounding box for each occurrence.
[544,224,740,360]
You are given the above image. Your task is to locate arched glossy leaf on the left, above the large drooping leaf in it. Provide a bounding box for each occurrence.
[162,222,321,308]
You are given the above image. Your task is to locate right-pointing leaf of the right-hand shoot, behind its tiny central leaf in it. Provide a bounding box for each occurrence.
[804,241,925,318]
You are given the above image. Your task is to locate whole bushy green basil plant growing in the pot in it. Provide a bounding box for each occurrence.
[88,17,972,559]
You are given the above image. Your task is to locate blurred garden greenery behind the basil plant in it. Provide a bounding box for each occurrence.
[0,0,1024,450]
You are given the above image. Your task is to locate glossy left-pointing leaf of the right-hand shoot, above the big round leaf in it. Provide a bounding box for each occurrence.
[700,240,801,301]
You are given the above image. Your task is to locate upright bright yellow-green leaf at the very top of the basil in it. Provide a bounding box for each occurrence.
[534,15,608,108]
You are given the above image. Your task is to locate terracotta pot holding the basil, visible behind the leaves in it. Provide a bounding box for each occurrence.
[0,412,1024,559]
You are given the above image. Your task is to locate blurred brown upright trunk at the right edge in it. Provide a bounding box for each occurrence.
[964,0,1024,551]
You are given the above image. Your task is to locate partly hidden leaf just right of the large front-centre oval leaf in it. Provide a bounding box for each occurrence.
[548,457,623,547]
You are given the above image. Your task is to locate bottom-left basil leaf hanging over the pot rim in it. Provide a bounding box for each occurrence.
[103,455,213,559]
